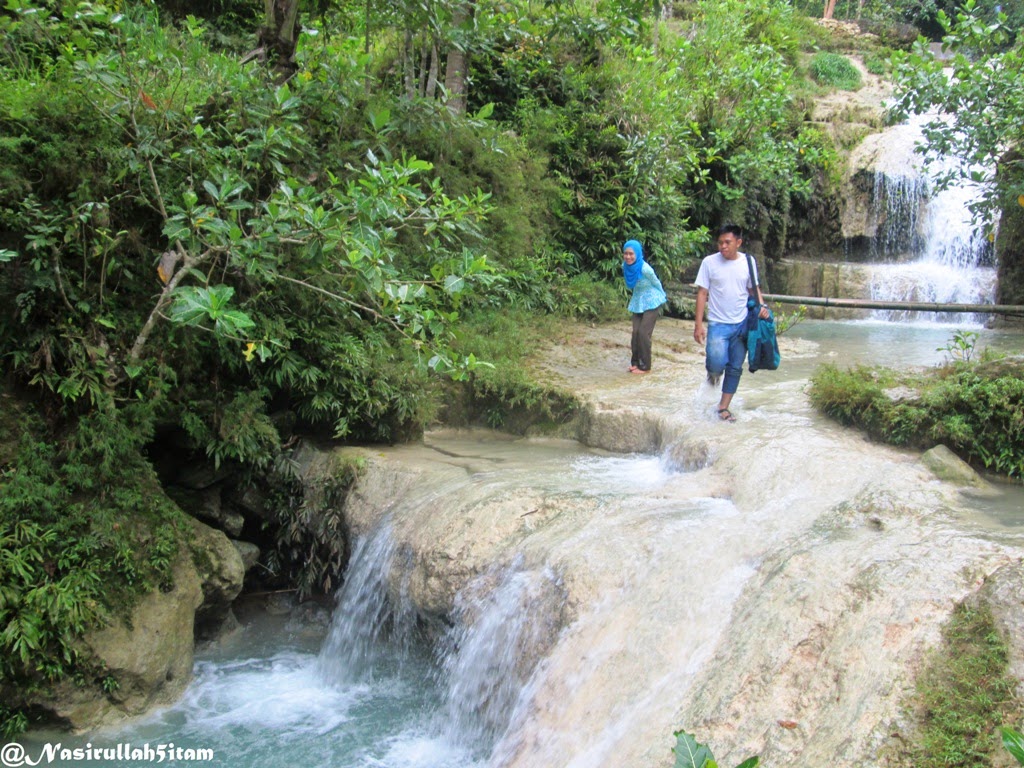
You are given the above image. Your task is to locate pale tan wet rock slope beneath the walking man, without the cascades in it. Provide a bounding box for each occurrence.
[321,321,1021,768]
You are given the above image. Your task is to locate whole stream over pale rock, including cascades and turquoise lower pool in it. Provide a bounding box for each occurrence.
[28,321,1024,768]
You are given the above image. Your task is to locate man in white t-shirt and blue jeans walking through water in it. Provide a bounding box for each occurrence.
[693,224,768,421]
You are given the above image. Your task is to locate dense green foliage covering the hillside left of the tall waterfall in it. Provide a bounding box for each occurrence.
[0,0,839,450]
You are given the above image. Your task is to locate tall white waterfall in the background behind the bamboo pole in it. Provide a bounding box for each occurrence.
[869,118,995,325]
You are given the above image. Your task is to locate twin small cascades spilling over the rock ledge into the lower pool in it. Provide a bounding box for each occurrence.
[317,522,564,758]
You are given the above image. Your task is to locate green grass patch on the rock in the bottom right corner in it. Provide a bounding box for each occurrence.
[905,603,1019,768]
